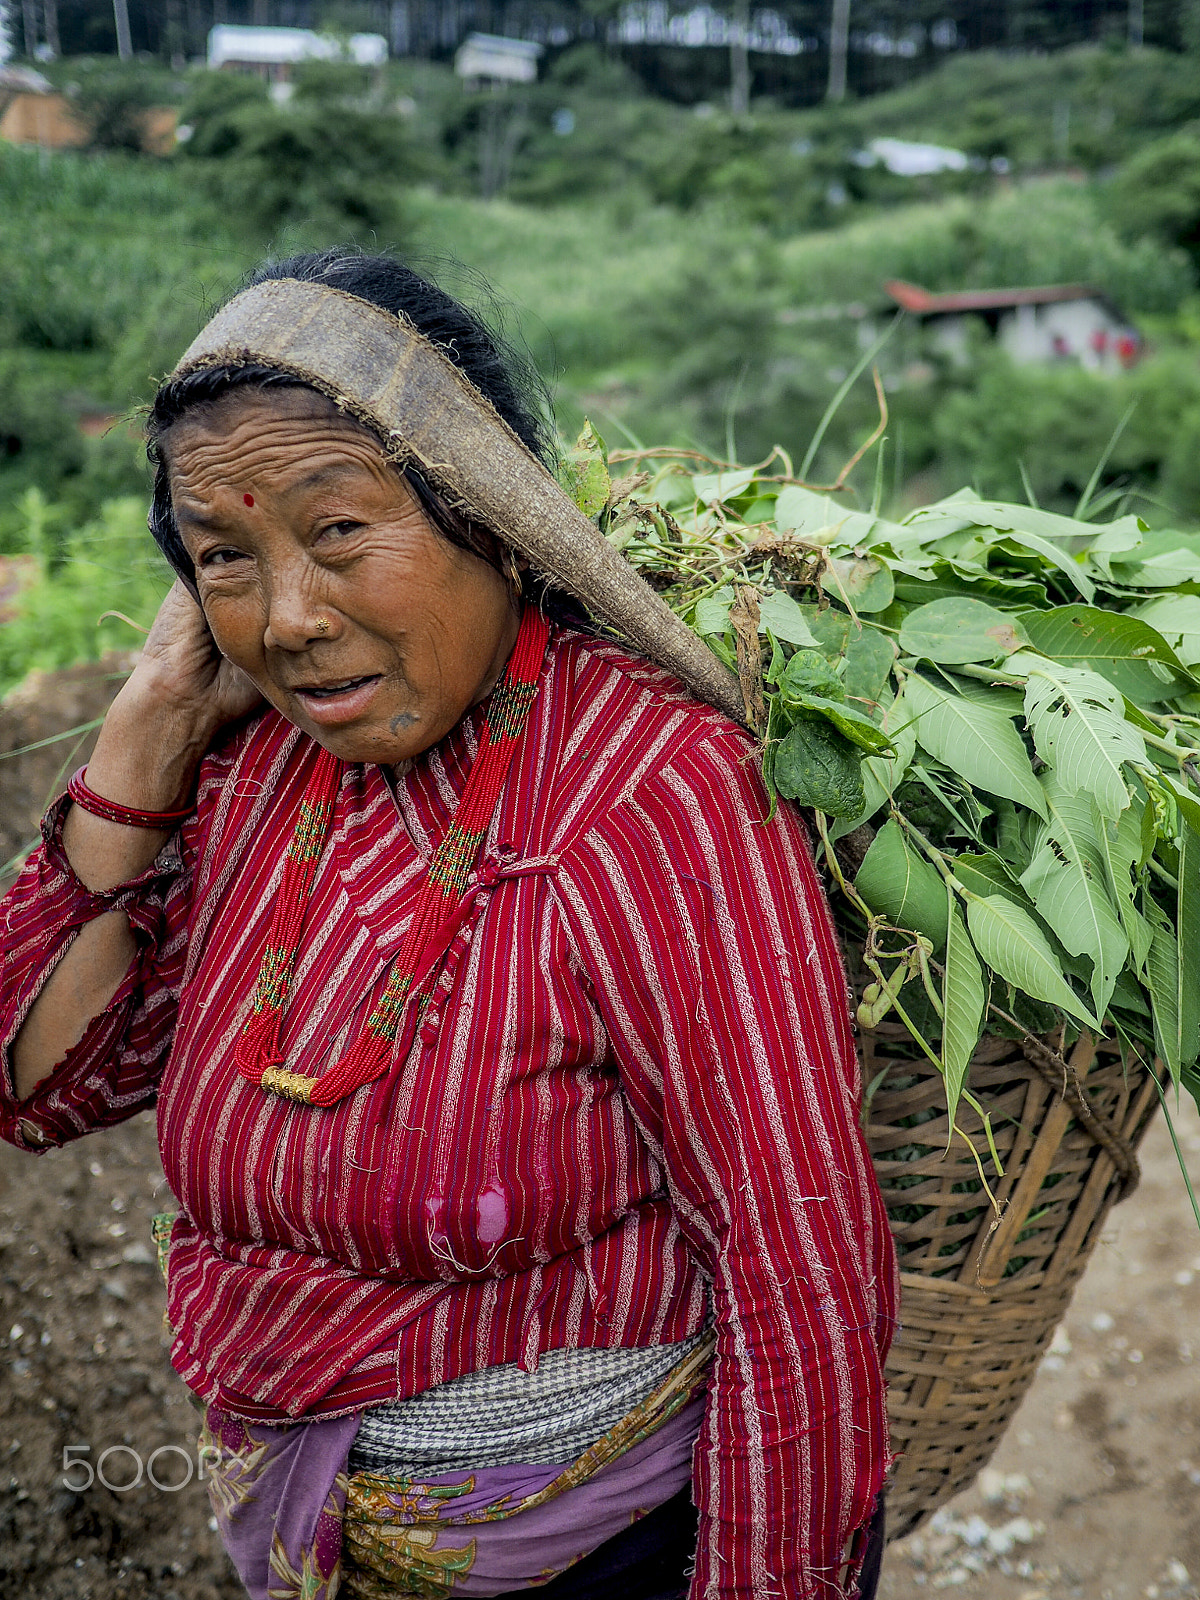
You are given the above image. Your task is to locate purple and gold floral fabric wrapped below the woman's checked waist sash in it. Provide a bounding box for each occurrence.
[202,1339,712,1600]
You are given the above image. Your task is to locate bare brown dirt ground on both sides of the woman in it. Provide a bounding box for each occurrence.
[0,661,1200,1600]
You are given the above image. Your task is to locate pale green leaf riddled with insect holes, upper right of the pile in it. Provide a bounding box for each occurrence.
[1026,658,1146,821]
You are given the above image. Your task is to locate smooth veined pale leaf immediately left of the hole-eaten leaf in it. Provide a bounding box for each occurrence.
[901,672,1046,816]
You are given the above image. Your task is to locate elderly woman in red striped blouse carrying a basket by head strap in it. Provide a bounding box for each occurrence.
[0,253,894,1600]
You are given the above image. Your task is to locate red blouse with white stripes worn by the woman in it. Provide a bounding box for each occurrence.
[0,630,896,1600]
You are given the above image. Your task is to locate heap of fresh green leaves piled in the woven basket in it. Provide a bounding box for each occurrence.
[620,448,1200,1126]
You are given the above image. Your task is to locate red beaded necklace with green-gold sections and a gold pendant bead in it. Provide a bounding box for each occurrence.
[235,606,549,1106]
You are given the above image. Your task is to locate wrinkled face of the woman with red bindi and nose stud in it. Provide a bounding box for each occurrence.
[163,389,520,765]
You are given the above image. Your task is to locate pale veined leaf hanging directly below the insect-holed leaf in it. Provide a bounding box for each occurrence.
[1021,773,1130,1016]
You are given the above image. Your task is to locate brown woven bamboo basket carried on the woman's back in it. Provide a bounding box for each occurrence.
[861,1022,1158,1538]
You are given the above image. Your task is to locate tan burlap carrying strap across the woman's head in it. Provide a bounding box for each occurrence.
[174,278,746,722]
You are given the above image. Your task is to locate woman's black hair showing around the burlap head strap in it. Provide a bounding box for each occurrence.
[146,246,582,622]
